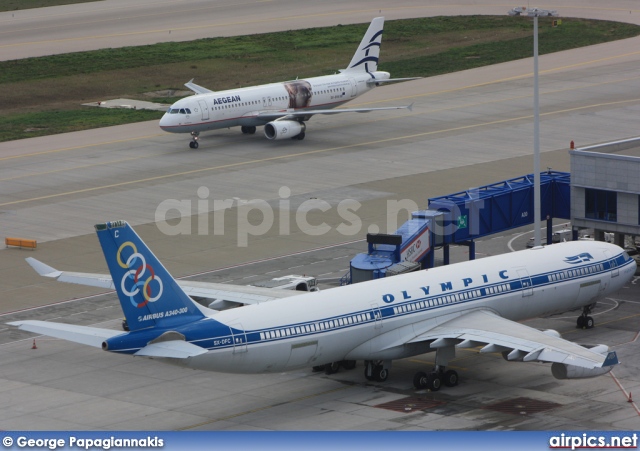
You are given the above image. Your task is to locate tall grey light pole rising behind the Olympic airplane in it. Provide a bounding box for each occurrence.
[533,12,548,248]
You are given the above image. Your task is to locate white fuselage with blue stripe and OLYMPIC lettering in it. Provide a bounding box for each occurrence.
[110,242,636,373]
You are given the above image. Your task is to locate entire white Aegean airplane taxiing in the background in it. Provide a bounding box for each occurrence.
[160,17,415,149]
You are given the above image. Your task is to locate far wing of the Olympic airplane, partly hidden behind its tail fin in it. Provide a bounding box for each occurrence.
[26,257,302,310]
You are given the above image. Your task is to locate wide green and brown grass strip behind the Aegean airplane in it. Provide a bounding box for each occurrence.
[0,16,640,141]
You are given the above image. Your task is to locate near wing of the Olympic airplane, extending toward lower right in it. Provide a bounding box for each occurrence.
[408,310,618,369]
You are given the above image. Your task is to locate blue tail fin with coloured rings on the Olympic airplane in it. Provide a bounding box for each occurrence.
[95,221,205,331]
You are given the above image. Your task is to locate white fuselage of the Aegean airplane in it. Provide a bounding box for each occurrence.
[160,71,389,133]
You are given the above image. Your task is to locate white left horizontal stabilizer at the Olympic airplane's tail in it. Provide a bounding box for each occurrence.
[7,320,122,348]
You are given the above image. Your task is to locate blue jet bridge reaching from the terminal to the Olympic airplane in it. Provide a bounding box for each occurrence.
[341,170,571,285]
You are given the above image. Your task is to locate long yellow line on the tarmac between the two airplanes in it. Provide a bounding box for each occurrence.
[5,99,640,207]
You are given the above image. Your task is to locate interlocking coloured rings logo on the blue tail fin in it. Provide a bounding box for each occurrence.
[116,241,163,308]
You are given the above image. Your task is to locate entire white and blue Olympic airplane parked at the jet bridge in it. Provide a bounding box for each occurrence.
[9,221,636,390]
